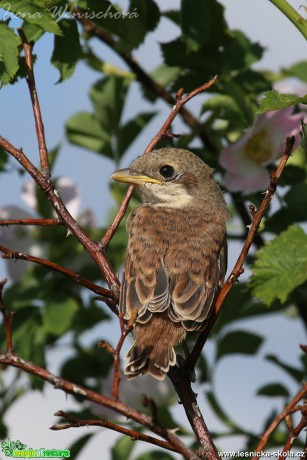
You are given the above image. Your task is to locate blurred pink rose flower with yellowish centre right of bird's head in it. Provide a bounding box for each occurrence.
[219,107,302,193]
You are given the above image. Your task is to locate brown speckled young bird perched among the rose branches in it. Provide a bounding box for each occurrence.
[111,148,228,380]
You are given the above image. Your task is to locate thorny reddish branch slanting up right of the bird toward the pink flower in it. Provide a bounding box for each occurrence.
[188,136,295,371]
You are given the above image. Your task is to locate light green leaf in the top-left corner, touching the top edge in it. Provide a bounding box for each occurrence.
[0,0,62,35]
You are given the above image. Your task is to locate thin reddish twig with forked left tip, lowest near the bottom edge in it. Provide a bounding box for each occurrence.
[50,410,180,453]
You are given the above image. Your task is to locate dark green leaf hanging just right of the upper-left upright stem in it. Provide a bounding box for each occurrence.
[51,19,82,83]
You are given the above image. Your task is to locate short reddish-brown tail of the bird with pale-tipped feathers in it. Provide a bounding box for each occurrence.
[125,314,185,380]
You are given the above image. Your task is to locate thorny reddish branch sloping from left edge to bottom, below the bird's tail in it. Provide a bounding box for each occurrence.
[0,353,199,460]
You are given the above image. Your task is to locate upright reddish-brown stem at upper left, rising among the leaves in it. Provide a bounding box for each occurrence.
[17,29,50,177]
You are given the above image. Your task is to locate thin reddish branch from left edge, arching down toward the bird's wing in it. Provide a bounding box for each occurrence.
[0,245,118,315]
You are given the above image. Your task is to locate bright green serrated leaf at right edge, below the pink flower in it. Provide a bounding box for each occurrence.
[251,226,307,305]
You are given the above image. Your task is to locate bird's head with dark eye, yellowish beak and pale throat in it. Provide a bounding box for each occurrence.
[111,148,224,208]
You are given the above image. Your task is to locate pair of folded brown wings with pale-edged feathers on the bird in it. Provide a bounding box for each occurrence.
[120,207,227,330]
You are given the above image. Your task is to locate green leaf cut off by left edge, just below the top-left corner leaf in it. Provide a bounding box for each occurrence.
[0,23,20,86]
